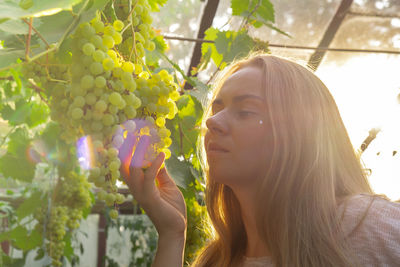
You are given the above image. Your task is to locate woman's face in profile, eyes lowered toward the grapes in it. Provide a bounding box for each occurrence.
[204,66,272,186]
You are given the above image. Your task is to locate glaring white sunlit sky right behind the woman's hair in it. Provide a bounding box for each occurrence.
[316,54,400,200]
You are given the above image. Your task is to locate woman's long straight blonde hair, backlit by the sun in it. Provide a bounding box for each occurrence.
[192,54,373,267]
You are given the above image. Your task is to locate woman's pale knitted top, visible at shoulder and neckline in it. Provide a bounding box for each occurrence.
[243,195,400,267]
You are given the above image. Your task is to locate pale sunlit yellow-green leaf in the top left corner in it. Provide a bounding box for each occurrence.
[0,0,81,19]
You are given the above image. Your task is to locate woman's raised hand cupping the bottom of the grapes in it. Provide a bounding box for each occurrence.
[119,136,186,237]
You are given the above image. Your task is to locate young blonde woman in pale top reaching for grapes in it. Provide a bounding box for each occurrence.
[123,55,400,267]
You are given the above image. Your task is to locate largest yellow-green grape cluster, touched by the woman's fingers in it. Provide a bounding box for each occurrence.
[47,9,179,221]
